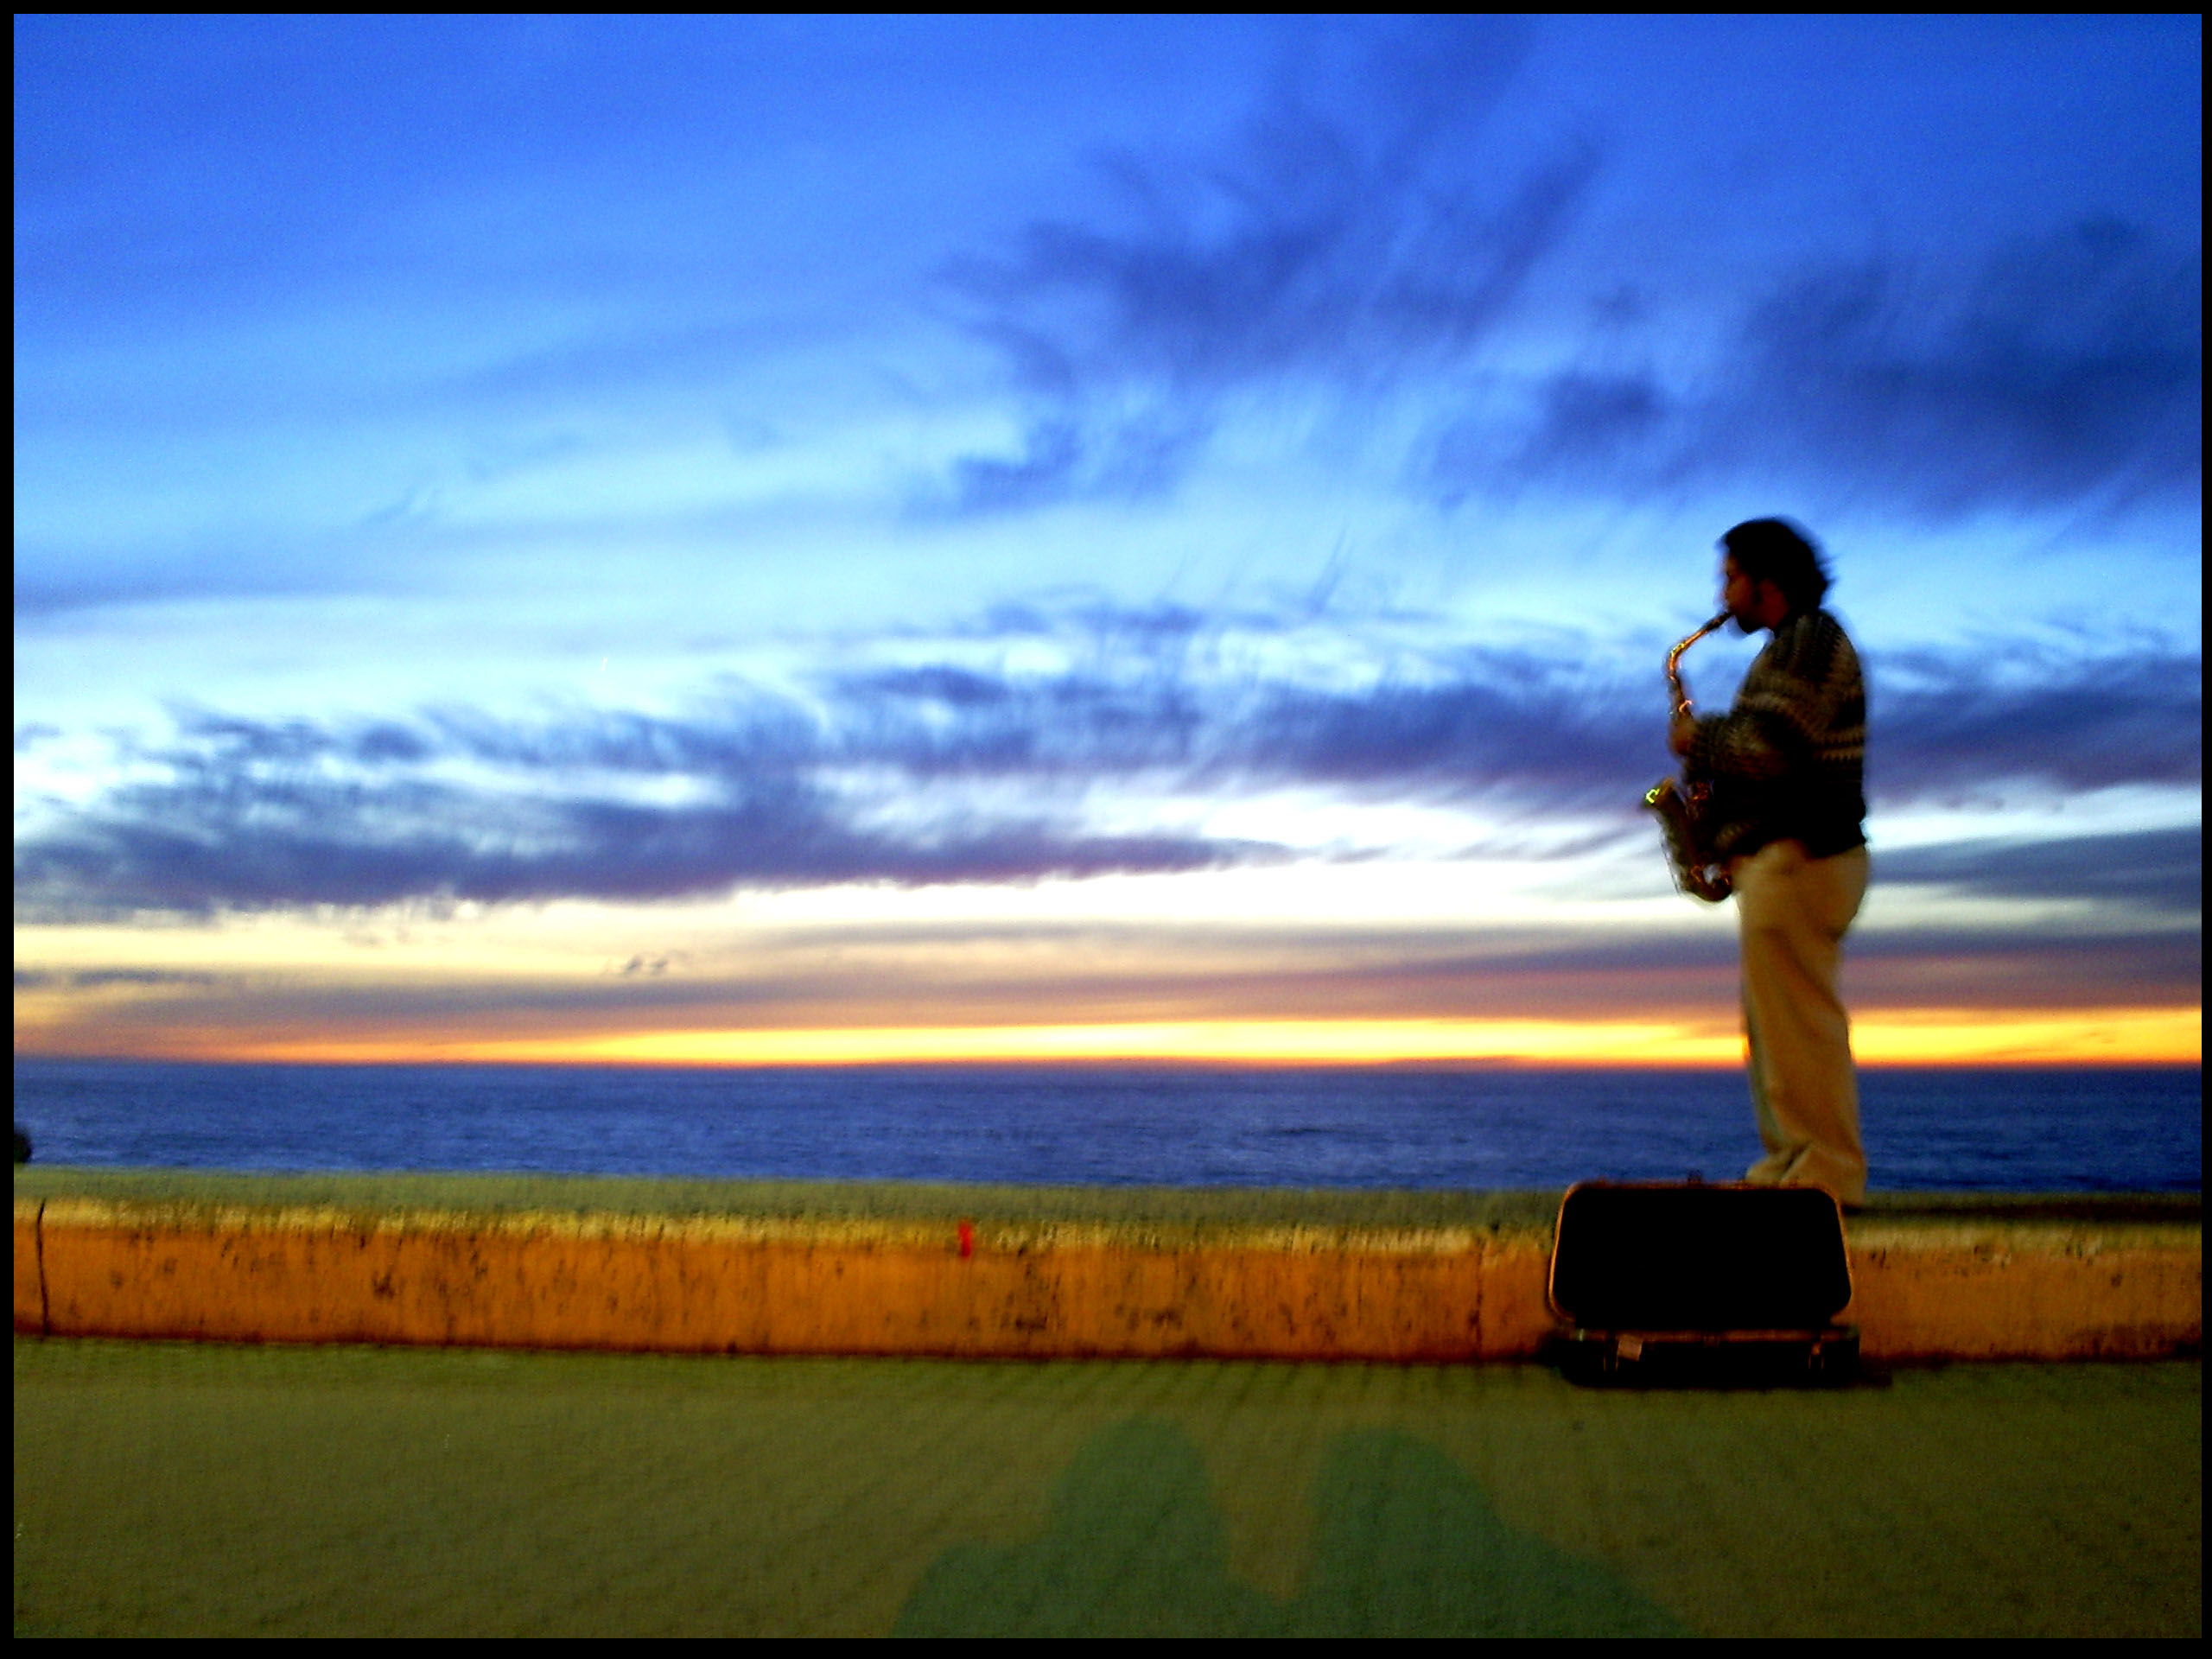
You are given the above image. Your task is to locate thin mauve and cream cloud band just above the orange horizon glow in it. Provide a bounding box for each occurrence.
[17,925,2203,1053]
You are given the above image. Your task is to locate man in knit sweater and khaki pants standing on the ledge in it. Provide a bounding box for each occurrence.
[1670,518,1867,1208]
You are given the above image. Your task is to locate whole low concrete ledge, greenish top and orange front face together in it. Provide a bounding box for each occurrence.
[16,1168,2203,1360]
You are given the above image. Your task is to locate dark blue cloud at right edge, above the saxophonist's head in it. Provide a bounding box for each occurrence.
[1431,217,2203,515]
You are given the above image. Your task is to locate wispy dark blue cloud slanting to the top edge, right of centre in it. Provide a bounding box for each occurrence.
[933,20,1597,511]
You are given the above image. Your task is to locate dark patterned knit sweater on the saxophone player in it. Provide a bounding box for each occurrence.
[1683,611,1867,858]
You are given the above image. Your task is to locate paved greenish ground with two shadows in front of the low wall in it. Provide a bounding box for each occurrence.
[16,1338,2203,1635]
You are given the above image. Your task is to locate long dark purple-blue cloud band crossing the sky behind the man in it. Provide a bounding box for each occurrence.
[16,613,2201,916]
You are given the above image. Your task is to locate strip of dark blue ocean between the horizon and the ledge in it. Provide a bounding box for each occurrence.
[16,1059,2203,1192]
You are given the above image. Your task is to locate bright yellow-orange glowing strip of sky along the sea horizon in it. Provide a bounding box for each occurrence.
[17,1008,2203,1068]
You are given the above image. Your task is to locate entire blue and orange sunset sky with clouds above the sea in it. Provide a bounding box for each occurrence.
[16,16,2203,1064]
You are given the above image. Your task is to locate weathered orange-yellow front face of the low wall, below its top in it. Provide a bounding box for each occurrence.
[16,1197,2203,1360]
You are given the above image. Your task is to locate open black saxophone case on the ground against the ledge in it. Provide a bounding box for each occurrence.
[1551,1181,1858,1387]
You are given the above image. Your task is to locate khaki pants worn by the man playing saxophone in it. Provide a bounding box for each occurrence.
[1730,841,1867,1204]
